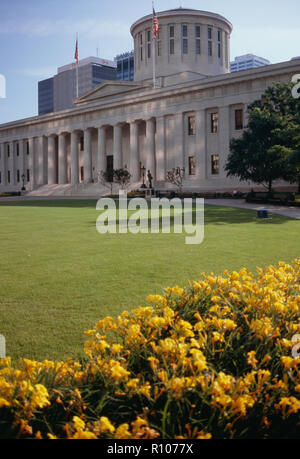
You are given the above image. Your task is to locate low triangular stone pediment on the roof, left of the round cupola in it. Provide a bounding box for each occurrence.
[74,81,149,105]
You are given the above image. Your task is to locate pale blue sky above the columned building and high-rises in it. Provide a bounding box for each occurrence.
[0,0,300,124]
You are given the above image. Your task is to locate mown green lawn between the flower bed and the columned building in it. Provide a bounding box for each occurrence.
[0,201,300,360]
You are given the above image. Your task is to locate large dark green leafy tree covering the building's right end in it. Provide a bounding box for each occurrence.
[225,83,300,192]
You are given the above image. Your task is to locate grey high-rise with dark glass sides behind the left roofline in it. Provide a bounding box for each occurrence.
[39,57,117,115]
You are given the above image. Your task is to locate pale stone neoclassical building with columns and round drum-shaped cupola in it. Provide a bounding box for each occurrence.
[0,8,300,195]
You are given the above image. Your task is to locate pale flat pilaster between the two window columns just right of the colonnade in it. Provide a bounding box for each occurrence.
[195,110,207,180]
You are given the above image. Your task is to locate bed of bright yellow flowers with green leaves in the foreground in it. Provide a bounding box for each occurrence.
[0,260,300,439]
